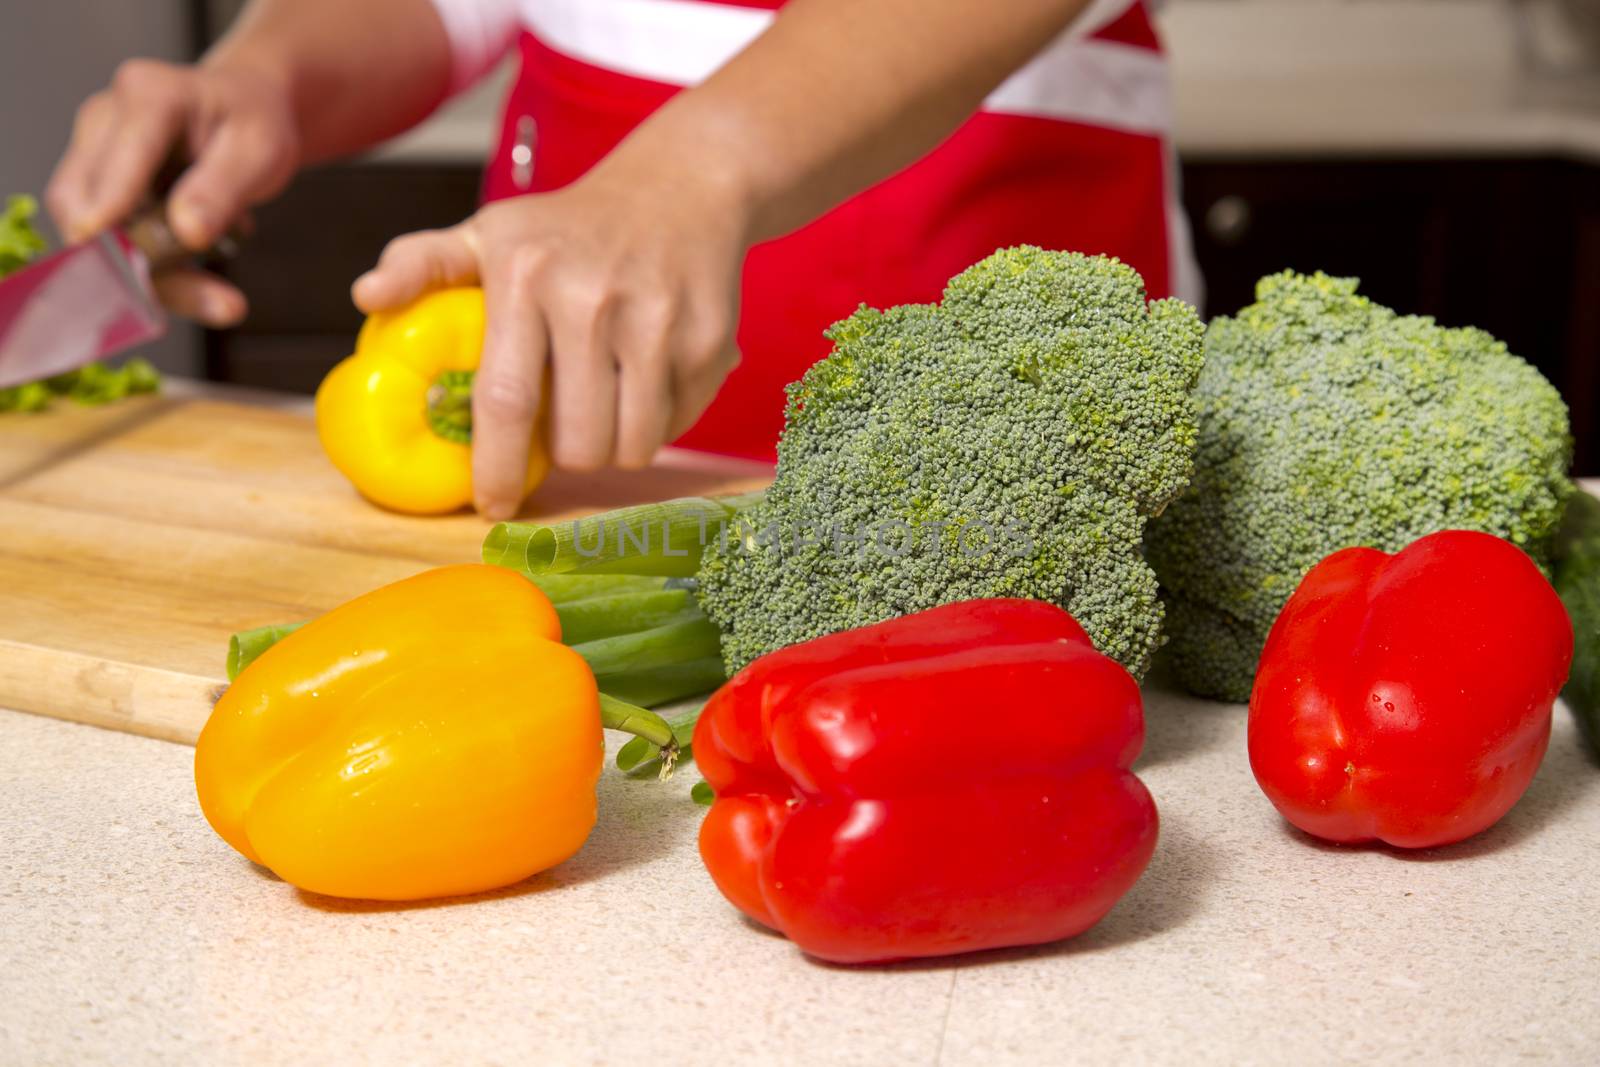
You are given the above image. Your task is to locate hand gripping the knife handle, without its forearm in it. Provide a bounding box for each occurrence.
[45,59,301,326]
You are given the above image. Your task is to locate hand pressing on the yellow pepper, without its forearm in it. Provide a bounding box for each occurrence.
[354,154,749,518]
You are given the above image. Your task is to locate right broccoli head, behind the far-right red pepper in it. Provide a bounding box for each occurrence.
[1149,272,1571,701]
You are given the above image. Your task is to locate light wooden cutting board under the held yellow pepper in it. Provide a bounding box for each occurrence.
[0,382,770,744]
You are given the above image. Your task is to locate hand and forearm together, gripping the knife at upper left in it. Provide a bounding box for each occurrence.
[45,0,450,326]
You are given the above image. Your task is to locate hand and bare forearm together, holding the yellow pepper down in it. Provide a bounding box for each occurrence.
[350,0,1088,517]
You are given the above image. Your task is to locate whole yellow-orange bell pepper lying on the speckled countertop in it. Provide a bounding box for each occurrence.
[195,563,603,901]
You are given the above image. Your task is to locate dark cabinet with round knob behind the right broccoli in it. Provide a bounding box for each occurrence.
[1182,160,1600,474]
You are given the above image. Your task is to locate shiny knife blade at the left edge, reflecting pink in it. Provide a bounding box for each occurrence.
[0,229,166,389]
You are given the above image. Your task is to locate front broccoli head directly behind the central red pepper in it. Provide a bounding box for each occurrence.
[699,246,1202,675]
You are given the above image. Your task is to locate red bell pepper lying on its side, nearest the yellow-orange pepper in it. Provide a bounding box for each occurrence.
[694,600,1157,963]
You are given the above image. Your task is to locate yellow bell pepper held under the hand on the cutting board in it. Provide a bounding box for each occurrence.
[317,288,550,515]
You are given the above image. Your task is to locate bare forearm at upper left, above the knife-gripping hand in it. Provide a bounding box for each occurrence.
[202,0,450,163]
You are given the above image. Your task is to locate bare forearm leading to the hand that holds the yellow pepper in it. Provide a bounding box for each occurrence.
[604,0,1088,240]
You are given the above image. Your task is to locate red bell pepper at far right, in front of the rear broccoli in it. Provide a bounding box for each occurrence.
[1250,530,1573,848]
